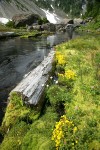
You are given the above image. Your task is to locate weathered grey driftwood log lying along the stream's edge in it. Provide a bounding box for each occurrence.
[10,49,55,105]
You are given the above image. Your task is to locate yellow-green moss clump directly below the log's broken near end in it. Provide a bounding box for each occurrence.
[2,92,39,133]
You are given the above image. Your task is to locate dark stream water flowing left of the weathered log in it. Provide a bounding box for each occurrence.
[0,32,78,129]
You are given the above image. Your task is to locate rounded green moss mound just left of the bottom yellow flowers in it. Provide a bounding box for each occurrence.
[22,107,57,150]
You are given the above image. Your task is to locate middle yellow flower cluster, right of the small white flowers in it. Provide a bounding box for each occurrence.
[58,69,76,80]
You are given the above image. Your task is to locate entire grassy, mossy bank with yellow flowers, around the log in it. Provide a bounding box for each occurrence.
[0,33,100,150]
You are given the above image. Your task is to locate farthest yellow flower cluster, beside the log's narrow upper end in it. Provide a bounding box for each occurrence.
[56,52,66,65]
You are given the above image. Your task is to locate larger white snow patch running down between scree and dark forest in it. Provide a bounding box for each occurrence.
[42,9,61,24]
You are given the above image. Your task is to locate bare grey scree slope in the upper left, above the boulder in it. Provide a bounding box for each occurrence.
[0,0,46,19]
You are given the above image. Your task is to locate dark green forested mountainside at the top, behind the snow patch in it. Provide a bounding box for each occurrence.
[33,0,86,17]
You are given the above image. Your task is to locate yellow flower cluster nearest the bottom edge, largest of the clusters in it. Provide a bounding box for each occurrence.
[52,115,73,150]
